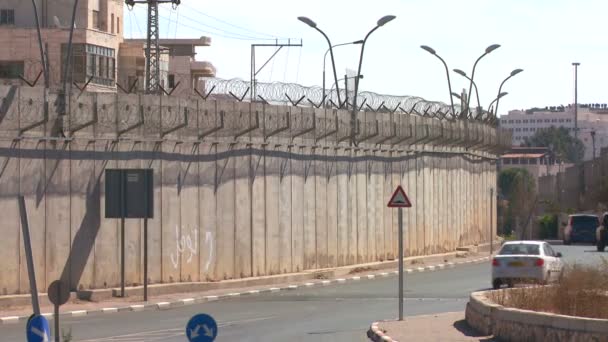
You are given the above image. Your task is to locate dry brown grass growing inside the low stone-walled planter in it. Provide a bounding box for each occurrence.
[490,258,608,319]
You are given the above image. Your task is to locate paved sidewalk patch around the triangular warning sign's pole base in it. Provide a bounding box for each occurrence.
[367,312,496,342]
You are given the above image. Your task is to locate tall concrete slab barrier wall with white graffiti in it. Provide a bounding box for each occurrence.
[0,86,508,294]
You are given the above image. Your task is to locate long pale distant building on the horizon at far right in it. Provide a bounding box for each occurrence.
[500,104,608,160]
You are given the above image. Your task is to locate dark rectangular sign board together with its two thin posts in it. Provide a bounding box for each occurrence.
[105,169,154,301]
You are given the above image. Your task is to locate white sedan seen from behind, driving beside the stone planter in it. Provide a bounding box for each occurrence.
[492,241,564,289]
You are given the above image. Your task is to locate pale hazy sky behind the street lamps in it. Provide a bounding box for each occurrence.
[124,0,608,114]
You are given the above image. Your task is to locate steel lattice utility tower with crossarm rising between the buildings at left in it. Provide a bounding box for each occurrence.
[125,0,181,94]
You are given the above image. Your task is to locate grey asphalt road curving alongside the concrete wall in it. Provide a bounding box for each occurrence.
[0,246,608,342]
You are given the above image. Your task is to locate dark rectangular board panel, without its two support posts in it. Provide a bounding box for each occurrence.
[105,169,154,218]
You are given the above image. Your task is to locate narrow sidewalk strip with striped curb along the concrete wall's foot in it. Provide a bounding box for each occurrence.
[0,240,498,324]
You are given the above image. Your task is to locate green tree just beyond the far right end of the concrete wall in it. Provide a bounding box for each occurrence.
[498,168,535,234]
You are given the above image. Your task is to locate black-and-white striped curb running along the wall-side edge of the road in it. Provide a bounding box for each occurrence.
[0,257,489,324]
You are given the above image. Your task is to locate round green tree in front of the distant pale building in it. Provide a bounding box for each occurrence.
[522,127,585,163]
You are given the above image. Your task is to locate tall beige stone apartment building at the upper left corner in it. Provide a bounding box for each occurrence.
[0,0,124,91]
